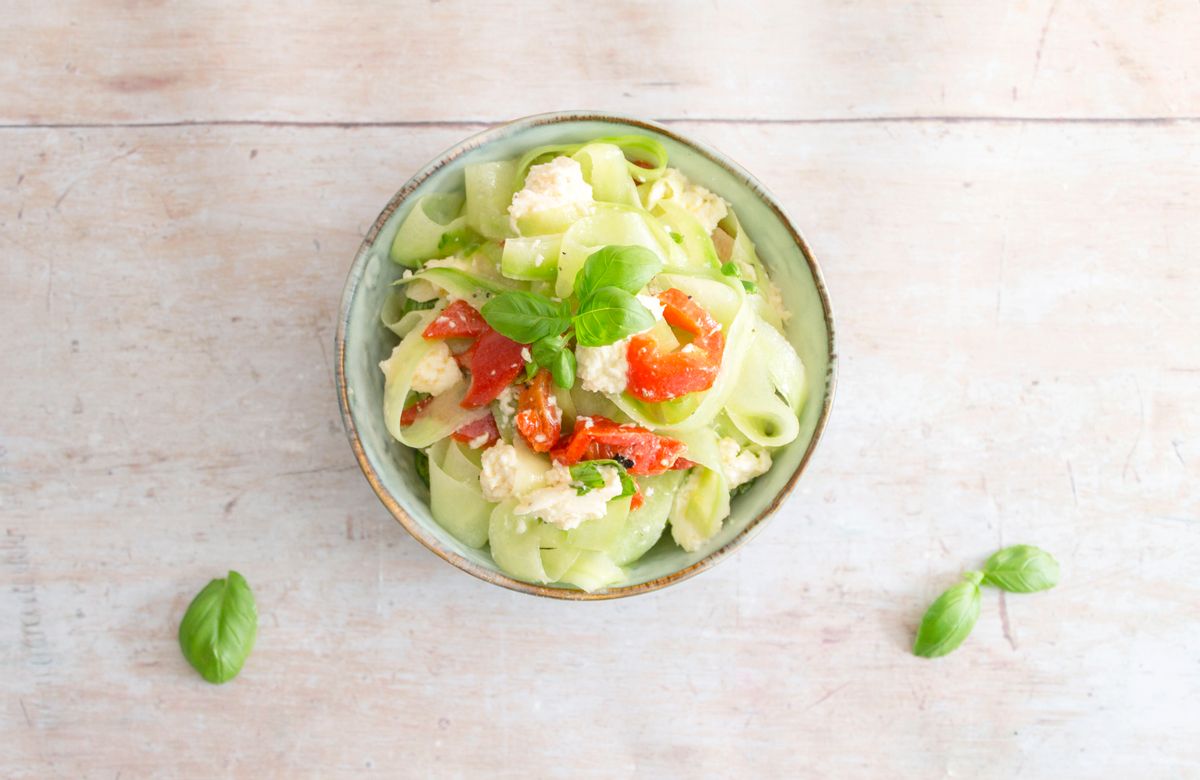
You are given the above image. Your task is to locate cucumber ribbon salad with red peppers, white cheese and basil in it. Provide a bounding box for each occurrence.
[379,134,806,592]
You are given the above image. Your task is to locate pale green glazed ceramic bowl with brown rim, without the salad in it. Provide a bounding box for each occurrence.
[336,112,836,600]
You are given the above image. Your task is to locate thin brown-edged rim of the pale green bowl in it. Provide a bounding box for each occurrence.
[334,110,838,601]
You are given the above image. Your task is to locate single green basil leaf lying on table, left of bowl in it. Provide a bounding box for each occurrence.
[179,571,258,684]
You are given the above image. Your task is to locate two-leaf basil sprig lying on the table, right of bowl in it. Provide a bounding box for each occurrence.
[912,545,1058,658]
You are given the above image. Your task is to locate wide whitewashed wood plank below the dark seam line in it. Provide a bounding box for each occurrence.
[0,124,1200,778]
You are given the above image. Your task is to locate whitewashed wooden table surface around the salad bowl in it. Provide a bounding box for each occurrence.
[0,0,1200,780]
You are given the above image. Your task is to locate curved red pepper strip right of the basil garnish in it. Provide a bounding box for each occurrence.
[625,287,725,402]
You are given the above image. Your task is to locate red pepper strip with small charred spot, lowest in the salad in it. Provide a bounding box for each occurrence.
[550,416,688,475]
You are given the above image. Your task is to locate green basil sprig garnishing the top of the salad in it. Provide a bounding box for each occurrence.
[481,246,662,389]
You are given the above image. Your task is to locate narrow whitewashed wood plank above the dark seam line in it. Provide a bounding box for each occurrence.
[0,0,1200,124]
